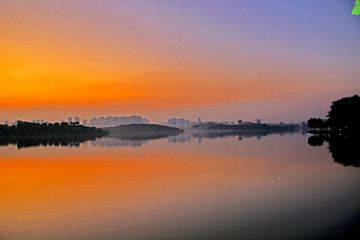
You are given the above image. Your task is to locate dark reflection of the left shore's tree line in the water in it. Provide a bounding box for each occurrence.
[0,134,102,149]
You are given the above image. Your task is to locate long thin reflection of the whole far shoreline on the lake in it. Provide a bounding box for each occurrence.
[0,131,294,149]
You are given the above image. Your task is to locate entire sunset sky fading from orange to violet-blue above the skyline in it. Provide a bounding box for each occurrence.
[0,0,360,124]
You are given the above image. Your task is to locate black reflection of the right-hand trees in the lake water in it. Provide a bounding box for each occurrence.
[308,135,360,167]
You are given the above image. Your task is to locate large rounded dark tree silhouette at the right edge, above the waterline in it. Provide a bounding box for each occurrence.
[327,95,360,134]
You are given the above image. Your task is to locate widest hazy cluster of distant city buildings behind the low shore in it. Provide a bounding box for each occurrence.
[89,116,149,127]
